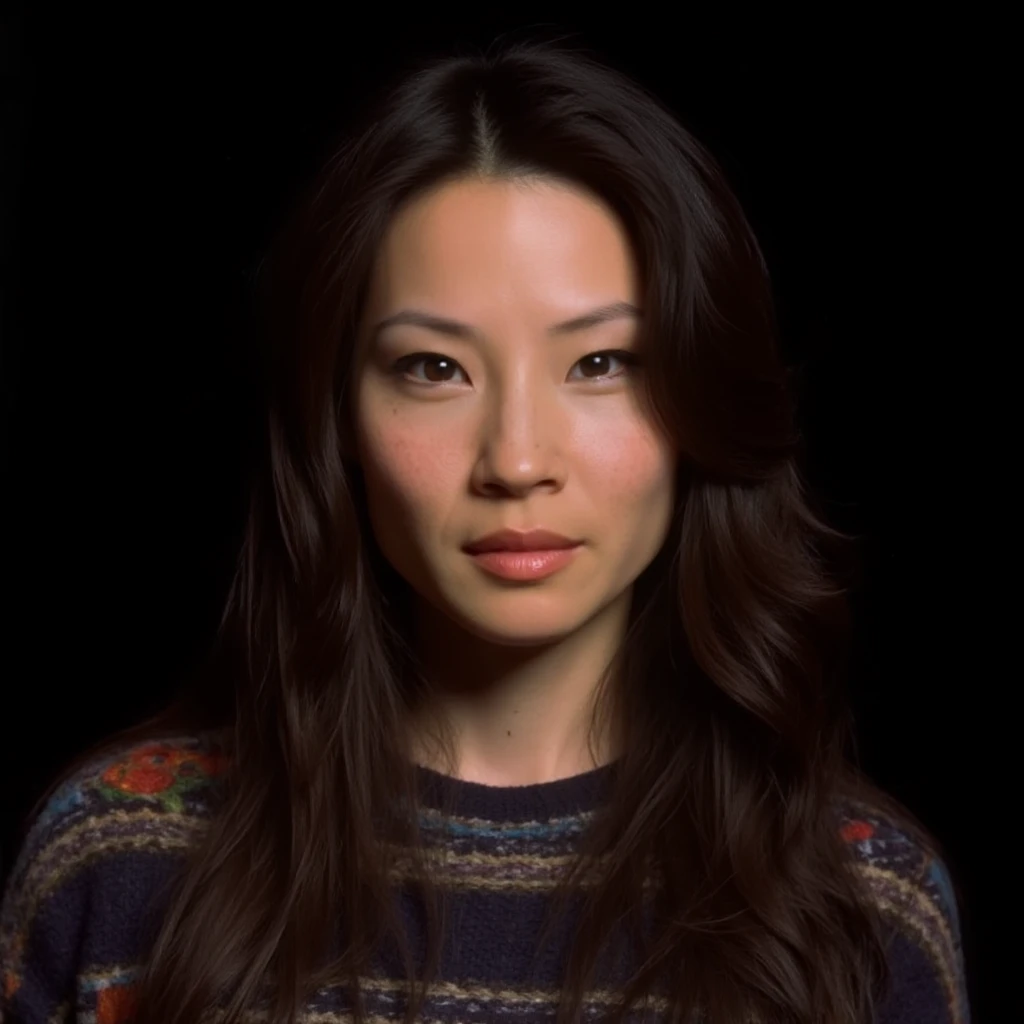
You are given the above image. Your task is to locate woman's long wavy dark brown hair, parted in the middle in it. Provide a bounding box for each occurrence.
[19,36,937,1024]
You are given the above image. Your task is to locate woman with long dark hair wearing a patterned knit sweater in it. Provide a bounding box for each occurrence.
[0,39,969,1024]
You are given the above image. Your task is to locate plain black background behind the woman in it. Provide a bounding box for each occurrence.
[0,5,1003,1020]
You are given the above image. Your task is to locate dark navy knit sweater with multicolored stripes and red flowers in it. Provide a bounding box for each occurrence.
[0,736,970,1024]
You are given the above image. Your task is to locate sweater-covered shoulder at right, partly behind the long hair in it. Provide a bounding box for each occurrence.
[840,803,970,1024]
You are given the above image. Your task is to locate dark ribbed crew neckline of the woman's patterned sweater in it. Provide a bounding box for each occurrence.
[416,761,618,822]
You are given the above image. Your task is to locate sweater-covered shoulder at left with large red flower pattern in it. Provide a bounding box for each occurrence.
[0,734,227,1021]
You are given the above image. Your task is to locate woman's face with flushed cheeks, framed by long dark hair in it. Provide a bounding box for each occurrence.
[355,179,675,645]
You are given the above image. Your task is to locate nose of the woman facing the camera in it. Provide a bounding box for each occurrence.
[472,374,570,498]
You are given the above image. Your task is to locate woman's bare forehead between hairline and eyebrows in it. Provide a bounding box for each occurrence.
[371,178,637,315]
